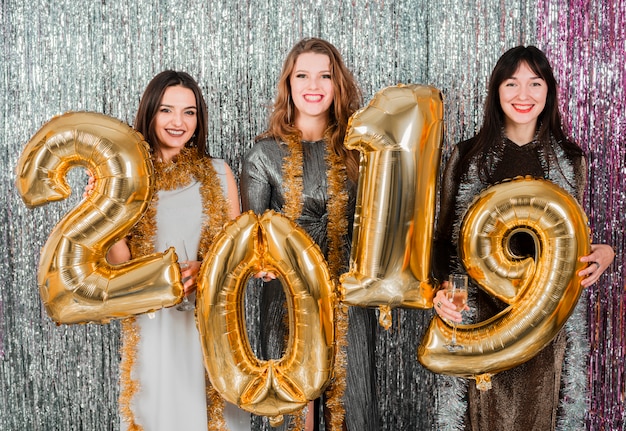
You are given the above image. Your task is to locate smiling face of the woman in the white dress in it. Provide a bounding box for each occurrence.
[154,85,198,160]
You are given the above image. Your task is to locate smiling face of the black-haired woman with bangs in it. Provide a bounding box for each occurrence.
[498,62,548,133]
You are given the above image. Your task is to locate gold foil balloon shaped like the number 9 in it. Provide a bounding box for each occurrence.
[418,177,590,389]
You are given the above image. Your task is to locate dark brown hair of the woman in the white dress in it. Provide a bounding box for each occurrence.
[134,70,208,157]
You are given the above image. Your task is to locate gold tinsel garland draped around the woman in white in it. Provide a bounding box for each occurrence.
[119,148,230,431]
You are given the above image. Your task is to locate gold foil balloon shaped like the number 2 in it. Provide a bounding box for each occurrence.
[16,112,183,324]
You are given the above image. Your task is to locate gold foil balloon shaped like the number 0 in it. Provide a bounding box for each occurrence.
[196,211,336,424]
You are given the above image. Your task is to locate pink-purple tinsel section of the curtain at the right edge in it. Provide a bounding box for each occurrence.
[537,0,626,430]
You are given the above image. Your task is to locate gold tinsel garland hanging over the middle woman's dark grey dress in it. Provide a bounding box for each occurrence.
[282,136,348,430]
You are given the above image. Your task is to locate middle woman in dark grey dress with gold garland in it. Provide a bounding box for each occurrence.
[240,38,379,431]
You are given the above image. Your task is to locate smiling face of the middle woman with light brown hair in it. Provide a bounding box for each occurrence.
[289,52,335,127]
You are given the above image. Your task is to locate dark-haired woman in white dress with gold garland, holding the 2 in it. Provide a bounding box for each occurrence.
[89,70,250,431]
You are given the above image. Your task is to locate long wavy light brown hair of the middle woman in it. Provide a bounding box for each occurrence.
[257,37,362,181]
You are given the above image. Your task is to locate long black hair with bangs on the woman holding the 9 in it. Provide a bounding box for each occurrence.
[462,45,583,180]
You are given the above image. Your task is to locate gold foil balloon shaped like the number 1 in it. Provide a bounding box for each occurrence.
[340,85,443,318]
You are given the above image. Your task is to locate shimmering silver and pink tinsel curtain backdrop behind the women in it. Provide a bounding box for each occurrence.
[0,0,626,430]
